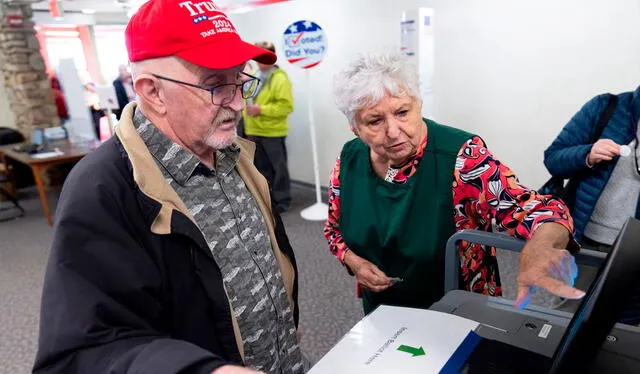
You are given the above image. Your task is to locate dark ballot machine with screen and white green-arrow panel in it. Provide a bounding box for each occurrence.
[310,218,640,374]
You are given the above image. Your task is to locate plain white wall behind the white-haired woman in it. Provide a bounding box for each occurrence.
[231,0,640,186]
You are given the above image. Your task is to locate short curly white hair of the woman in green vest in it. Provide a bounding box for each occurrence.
[333,52,422,125]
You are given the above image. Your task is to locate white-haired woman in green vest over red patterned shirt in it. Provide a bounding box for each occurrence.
[325,54,584,313]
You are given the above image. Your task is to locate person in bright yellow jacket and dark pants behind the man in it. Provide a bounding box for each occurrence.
[244,42,293,213]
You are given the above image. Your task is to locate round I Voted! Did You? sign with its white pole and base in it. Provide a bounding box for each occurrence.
[283,20,329,221]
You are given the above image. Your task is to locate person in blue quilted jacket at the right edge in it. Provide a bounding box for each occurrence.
[544,87,640,325]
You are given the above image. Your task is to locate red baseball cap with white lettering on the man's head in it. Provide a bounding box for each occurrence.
[125,0,277,70]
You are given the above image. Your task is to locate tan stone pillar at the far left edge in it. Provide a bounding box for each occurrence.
[0,3,60,137]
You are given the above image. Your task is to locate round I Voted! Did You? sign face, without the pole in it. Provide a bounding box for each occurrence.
[283,20,327,69]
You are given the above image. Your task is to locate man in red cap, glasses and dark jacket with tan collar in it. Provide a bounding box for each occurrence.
[34,0,304,374]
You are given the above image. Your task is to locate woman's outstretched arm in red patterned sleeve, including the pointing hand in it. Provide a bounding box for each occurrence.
[453,137,584,308]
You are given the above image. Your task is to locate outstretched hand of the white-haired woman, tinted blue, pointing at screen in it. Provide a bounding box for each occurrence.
[514,222,585,309]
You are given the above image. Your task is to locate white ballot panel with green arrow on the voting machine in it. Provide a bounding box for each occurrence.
[309,305,479,374]
